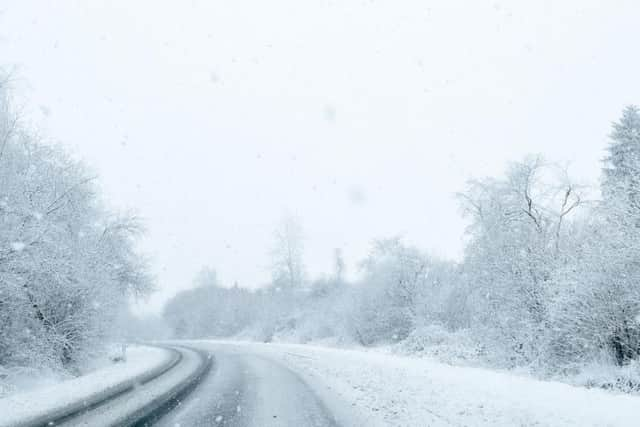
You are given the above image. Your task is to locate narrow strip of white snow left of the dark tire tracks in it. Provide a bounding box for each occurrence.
[0,346,175,427]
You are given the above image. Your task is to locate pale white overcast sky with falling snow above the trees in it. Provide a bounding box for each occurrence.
[0,0,640,310]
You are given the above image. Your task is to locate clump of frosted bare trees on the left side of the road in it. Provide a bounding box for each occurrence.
[0,74,152,382]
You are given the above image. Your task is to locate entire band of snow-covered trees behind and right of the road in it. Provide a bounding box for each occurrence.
[165,106,640,382]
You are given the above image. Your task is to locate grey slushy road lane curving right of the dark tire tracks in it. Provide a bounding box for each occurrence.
[154,344,338,427]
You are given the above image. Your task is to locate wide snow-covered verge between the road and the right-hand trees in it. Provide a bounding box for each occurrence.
[208,342,640,427]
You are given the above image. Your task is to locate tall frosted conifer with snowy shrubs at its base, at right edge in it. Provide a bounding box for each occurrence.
[552,106,640,365]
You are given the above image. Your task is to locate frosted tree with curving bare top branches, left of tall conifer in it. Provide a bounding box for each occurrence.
[460,157,582,364]
